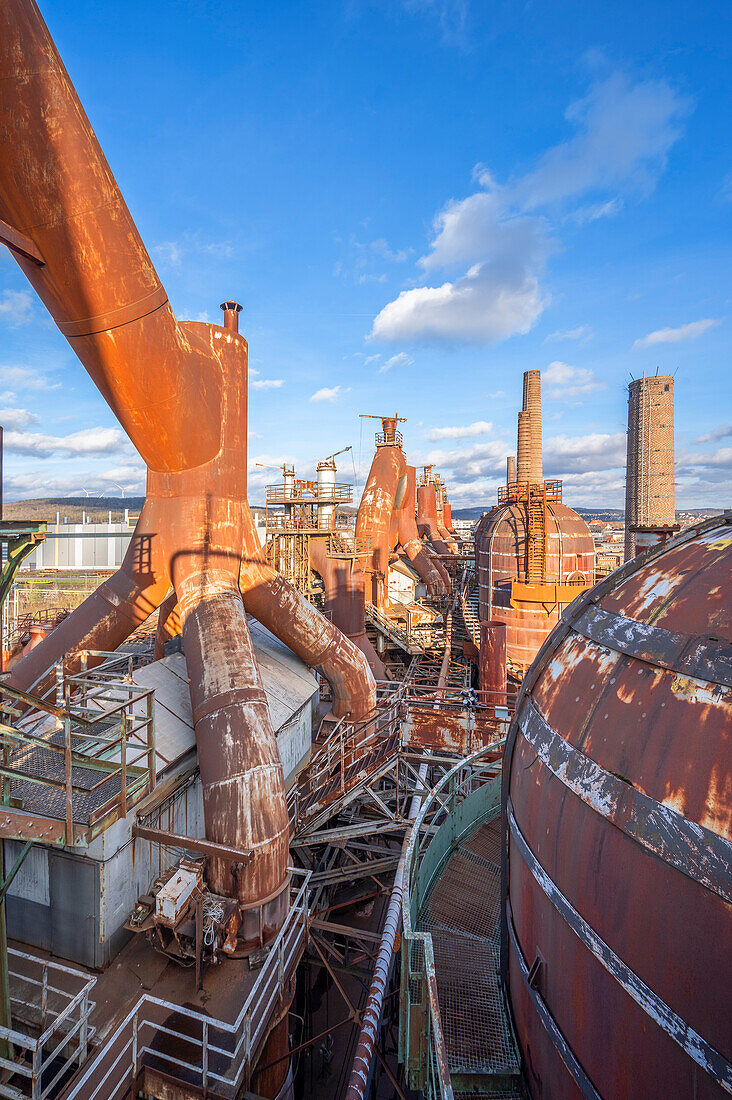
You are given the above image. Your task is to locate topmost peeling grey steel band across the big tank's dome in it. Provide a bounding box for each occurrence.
[572,604,732,688]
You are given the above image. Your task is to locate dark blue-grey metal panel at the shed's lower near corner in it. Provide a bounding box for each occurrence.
[48,851,103,967]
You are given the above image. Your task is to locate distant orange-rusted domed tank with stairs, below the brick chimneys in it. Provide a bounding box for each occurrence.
[476,497,594,671]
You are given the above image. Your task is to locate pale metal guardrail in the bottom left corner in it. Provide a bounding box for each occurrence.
[0,947,97,1100]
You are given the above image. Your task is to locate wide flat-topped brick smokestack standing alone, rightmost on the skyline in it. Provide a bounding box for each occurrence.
[625,374,676,561]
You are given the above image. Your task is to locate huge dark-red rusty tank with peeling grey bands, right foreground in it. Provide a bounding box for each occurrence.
[502,513,732,1100]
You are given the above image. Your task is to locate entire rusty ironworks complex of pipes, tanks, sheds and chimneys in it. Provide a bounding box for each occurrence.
[0,0,732,1100]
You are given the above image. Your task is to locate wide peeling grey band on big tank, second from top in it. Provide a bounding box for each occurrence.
[518,697,732,903]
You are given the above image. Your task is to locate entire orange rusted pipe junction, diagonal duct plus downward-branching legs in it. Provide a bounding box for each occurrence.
[0,0,375,990]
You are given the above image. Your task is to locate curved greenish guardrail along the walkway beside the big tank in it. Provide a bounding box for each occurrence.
[398,738,505,1100]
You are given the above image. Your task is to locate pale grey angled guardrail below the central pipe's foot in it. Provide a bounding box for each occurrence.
[64,868,310,1100]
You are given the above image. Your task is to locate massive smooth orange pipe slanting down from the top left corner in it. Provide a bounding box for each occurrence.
[0,0,221,471]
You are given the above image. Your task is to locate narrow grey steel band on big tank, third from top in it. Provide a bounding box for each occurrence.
[507,799,732,1093]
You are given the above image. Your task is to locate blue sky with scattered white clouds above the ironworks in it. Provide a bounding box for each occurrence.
[0,0,732,507]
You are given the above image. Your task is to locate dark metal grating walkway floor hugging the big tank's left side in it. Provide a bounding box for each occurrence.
[419,818,522,1082]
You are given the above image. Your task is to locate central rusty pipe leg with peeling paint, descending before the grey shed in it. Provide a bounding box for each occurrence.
[176,572,288,939]
